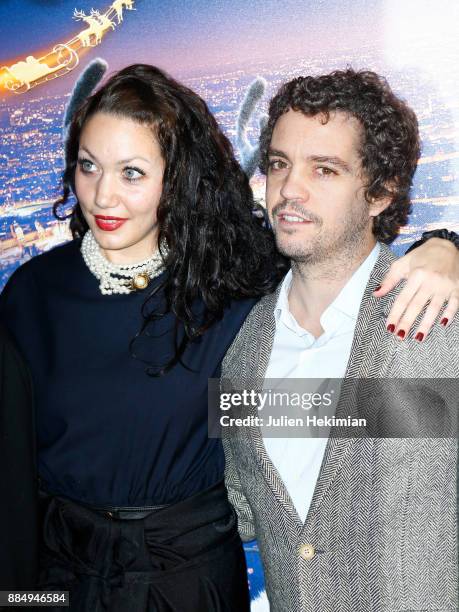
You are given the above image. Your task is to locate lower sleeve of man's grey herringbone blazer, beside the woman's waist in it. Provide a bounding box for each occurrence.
[222,438,256,542]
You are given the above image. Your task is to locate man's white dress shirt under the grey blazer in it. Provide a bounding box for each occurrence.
[264,244,380,523]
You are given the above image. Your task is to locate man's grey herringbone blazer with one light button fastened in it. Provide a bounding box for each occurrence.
[222,247,459,612]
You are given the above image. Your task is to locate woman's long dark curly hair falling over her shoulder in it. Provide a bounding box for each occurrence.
[54,64,286,375]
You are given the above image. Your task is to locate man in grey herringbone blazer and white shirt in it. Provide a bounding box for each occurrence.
[222,70,459,612]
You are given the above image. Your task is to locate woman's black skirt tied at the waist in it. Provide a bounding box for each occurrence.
[39,483,250,612]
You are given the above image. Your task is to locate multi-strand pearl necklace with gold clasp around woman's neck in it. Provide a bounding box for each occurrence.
[81,229,164,295]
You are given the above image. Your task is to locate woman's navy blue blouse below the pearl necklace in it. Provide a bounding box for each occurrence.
[0,241,255,506]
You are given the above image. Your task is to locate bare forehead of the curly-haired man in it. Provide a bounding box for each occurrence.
[270,109,363,157]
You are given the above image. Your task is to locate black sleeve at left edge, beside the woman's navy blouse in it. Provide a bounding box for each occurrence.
[0,326,38,590]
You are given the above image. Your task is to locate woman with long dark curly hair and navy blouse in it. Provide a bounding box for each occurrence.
[2,65,458,612]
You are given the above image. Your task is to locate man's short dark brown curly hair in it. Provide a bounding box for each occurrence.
[260,69,421,244]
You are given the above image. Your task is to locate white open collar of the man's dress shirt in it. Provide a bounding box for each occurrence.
[274,243,381,335]
